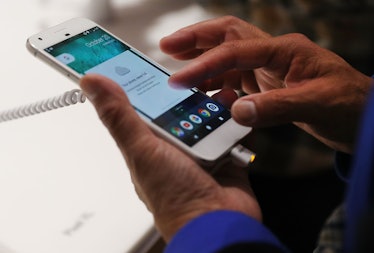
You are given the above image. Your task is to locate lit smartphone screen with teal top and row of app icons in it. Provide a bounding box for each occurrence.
[44,27,231,146]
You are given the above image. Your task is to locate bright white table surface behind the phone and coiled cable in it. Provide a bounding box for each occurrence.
[0,0,216,253]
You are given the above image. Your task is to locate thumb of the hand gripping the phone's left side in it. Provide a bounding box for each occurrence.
[80,74,151,156]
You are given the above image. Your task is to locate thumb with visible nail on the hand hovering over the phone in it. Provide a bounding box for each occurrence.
[231,87,319,127]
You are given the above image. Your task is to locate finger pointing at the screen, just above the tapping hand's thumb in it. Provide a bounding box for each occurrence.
[169,34,316,88]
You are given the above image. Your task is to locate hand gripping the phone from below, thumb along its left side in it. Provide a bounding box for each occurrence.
[81,75,261,241]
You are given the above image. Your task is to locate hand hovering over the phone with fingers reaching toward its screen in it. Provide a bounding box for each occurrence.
[160,17,371,153]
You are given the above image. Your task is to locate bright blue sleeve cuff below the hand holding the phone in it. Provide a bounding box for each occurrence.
[165,211,288,253]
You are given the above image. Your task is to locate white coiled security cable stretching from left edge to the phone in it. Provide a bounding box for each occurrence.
[0,89,86,123]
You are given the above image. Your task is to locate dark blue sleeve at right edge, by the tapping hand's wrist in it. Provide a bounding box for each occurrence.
[344,84,374,252]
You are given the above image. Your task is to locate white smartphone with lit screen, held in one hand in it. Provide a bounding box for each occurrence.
[27,18,251,165]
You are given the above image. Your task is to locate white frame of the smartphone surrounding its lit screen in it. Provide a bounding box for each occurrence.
[26,18,252,165]
